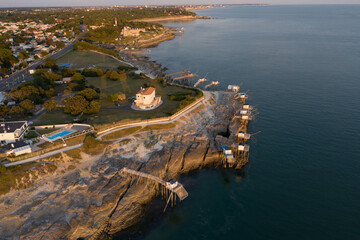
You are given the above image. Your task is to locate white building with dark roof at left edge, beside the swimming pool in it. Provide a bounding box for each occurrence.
[0,121,29,145]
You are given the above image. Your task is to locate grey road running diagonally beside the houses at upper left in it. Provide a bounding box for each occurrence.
[0,26,87,92]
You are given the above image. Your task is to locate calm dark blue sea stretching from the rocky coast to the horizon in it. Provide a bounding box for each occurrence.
[125,5,360,240]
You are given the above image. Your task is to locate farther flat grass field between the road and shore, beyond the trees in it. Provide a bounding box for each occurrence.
[56,50,129,69]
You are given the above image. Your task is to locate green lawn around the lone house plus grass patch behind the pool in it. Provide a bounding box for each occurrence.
[35,77,195,128]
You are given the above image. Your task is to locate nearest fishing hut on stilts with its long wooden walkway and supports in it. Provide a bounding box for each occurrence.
[121,167,189,212]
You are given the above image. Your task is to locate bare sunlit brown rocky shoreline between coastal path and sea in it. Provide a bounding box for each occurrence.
[0,17,248,239]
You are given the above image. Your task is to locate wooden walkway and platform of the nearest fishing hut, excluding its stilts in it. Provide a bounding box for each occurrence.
[121,167,189,201]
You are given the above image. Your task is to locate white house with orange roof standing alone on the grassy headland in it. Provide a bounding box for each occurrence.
[135,87,161,109]
